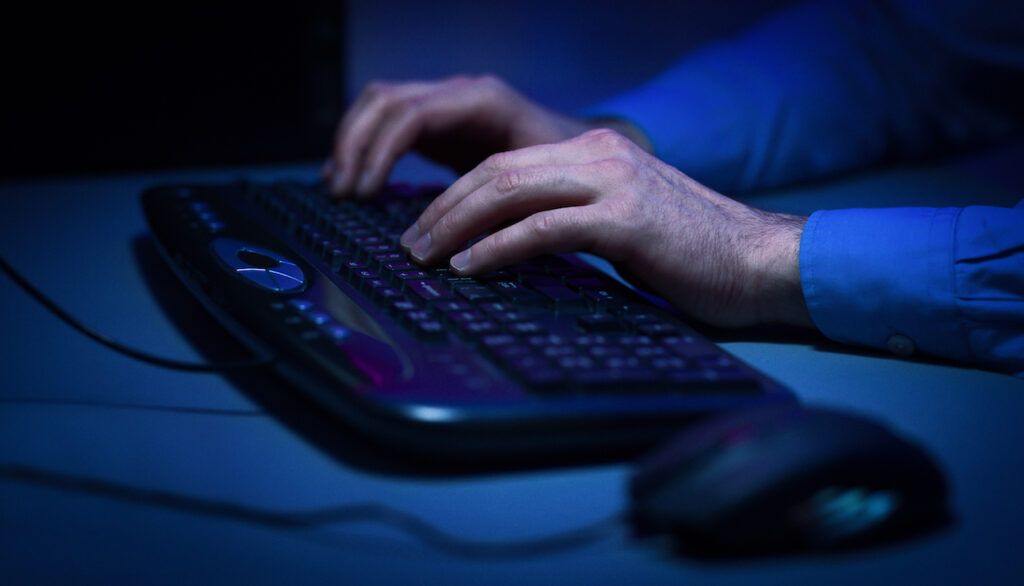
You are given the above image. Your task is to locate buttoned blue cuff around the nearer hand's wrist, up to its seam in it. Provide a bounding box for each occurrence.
[800,208,971,361]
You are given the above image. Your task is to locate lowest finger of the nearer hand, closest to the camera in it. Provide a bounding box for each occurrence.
[450,206,600,275]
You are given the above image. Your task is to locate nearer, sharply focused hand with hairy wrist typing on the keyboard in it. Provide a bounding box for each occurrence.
[401,129,813,326]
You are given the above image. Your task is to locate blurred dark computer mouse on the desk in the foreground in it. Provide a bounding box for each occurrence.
[630,406,949,556]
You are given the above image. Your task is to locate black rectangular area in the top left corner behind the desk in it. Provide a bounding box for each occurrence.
[0,0,344,176]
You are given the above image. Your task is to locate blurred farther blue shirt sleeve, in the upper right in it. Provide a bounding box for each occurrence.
[585,0,1024,193]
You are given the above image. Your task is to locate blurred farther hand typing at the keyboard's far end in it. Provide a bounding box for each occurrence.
[322,76,589,197]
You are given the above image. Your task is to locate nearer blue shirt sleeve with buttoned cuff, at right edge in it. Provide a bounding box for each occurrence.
[800,201,1024,377]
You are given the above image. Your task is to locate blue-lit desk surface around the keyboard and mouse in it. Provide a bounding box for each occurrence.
[0,149,1024,584]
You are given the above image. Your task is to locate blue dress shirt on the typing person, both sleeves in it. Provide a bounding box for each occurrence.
[589,0,1024,377]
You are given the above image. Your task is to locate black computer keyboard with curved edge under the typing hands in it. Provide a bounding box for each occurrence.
[142,182,794,459]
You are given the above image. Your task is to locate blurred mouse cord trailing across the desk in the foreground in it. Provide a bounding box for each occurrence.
[0,463,624,558]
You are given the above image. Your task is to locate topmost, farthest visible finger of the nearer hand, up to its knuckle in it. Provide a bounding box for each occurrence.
[401,134,606,249]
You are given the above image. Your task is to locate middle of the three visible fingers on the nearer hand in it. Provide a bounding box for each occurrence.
[411,164,601,263]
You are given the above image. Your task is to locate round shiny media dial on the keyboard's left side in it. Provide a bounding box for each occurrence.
[210,238,306,293]
